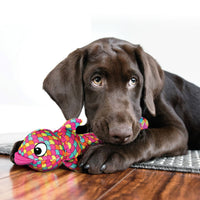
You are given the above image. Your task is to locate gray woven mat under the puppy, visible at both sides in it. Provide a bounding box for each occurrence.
[0,144,200,173]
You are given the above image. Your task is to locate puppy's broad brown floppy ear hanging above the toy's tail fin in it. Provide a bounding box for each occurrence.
[43,49,84,119]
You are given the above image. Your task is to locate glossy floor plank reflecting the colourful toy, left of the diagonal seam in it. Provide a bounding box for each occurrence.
[0,156,134,200]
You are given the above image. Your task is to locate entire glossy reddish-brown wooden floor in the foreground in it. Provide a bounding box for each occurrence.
[0,156,200,200]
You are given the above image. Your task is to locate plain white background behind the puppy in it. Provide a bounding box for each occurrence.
[0,0,200,141]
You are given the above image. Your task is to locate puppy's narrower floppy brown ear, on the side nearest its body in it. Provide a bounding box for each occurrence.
[135,45,164,116]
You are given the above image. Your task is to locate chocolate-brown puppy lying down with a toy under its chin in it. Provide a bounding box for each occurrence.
[11,38,200,174]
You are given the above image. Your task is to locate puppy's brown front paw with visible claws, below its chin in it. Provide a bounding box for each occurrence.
[79,144,130,174]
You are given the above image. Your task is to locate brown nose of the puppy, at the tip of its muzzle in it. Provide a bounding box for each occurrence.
[109,126,133,144]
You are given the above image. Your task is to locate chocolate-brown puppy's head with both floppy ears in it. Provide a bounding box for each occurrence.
[44,38,164,144]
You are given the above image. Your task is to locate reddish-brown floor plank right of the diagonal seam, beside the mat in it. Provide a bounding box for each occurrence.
[98,169,200,200]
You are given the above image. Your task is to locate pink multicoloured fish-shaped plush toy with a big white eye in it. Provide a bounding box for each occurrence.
[14,117,148,171]
